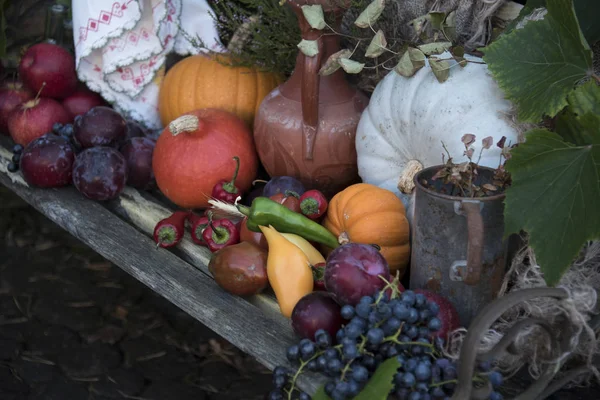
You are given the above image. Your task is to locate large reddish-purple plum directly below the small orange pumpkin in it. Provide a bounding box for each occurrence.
[325,243,390,305]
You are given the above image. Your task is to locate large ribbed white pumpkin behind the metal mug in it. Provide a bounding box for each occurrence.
[356,52,518,214]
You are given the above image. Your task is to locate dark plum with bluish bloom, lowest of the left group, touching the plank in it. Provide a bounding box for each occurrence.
[73,147,127,201]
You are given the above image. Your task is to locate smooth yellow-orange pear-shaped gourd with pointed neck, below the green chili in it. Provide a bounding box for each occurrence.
[259,225,314,318]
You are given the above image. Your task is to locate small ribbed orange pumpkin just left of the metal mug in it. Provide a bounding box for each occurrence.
[323,183,410,276]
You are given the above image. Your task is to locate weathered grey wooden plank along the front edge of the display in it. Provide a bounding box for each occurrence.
[0,146,323,394]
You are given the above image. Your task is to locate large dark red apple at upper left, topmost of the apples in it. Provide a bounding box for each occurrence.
[19,43,77,99]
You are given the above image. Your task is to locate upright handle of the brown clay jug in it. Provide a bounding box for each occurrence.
[301,37,323,160]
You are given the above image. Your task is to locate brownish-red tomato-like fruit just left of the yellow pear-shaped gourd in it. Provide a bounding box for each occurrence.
[208,242,269,296]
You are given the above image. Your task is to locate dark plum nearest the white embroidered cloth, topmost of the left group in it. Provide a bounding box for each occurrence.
[73,106,127,149]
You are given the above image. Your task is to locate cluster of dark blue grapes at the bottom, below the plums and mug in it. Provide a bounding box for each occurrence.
[268,290,502,400]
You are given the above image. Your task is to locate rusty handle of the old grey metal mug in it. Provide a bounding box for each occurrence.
[450,200,484,285]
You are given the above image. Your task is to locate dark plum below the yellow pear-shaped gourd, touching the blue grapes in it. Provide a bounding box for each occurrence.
[292,292,343,340]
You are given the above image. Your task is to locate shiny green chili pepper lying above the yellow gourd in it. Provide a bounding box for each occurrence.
[237,197,339,249]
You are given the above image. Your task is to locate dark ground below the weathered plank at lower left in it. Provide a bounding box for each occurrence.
[0,187,271,400]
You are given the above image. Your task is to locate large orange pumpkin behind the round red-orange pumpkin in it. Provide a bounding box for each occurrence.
[158,54,283,127]
